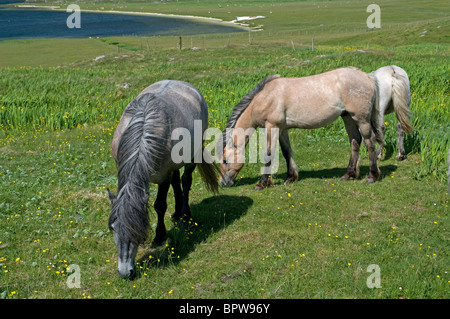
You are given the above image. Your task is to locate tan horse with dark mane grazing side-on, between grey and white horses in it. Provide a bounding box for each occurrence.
[221,67,381,190]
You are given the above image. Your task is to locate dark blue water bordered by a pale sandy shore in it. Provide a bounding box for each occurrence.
[0,0,242,40]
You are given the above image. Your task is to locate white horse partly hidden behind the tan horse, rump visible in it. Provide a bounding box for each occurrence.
[370,65,412,160]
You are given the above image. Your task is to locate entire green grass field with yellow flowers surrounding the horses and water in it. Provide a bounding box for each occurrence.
[0,1,450,299]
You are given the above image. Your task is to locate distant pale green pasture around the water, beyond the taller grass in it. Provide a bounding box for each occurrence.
[0,0,450,67]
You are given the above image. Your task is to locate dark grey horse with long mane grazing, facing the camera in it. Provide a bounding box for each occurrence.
[108,80,219,278]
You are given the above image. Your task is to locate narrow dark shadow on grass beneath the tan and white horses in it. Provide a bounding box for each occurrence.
[232,165,397,187]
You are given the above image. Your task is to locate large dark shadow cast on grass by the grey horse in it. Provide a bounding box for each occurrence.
[136,195,253,277]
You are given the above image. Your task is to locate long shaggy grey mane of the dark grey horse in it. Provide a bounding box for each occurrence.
[109,93,170,245]
